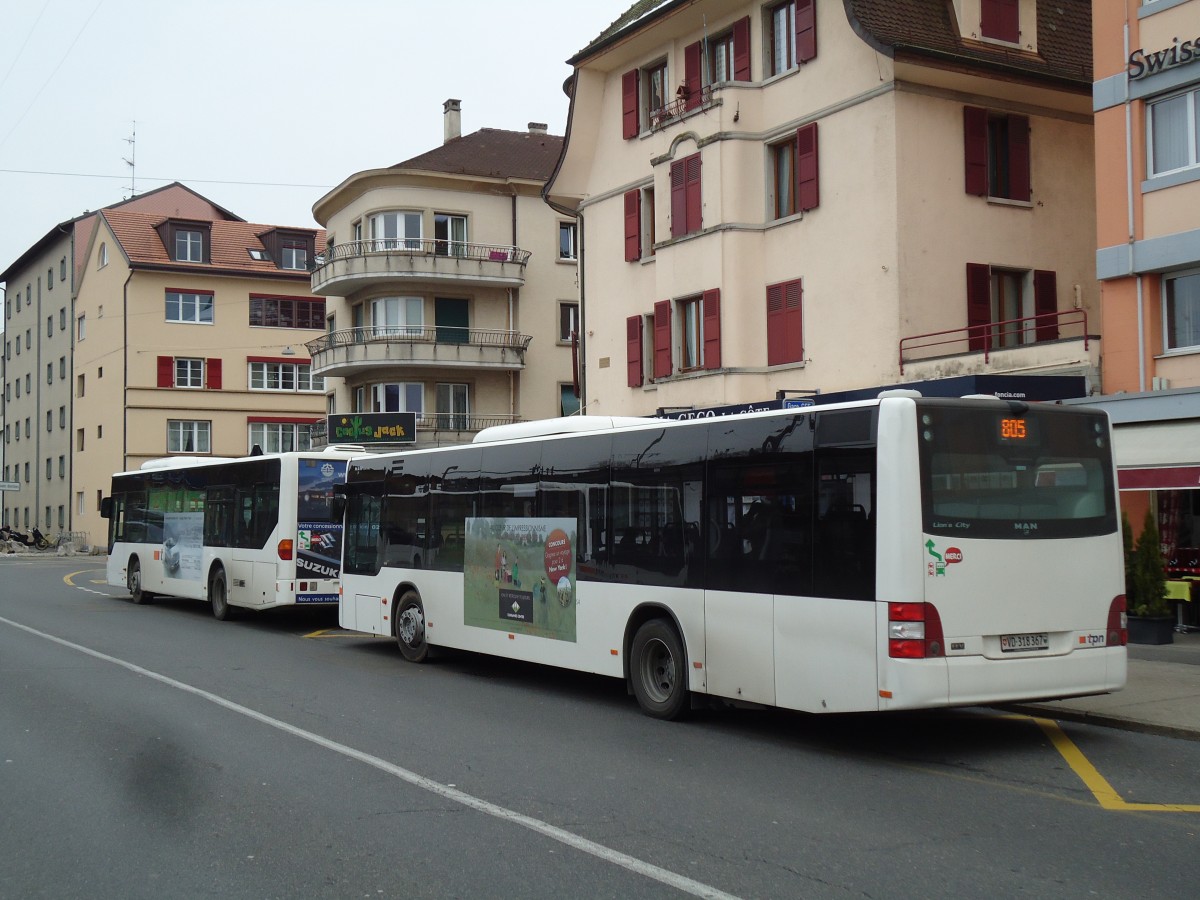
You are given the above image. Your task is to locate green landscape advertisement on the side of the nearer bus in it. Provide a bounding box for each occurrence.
[463,517,576,642]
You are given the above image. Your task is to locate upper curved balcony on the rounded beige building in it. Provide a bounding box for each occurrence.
[312,238,529,296]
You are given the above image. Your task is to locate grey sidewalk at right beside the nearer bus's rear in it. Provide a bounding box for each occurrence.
[1008,632,1200,740]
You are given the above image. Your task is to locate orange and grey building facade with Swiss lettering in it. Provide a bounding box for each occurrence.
[1093,0,1200,602]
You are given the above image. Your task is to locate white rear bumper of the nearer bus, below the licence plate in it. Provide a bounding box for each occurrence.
[880,647,1127,709]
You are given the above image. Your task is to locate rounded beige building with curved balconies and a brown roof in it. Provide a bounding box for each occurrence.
[308,100,578,446]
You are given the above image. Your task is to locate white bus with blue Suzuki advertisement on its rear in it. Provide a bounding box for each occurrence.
[102,448,353,619]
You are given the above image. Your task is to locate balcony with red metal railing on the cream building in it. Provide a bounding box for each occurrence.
[899,310,1100,380]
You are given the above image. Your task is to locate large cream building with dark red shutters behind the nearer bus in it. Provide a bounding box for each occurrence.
[546,0,1099,414]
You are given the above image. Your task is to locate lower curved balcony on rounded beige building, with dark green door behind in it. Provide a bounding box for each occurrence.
[305,325,533,378]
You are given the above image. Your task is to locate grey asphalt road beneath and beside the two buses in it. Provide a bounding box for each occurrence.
[0,557,1200,898]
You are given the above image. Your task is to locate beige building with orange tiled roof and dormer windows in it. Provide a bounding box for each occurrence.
[70,186,325,541]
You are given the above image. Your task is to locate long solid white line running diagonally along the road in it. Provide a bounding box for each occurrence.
[0,617,737,900]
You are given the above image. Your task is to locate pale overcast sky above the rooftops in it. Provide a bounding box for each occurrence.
[0,0,632,278]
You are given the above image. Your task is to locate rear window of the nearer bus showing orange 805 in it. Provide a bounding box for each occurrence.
[917,401,1117,539]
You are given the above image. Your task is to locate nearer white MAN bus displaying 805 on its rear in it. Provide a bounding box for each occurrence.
[338,391,1126,718]
